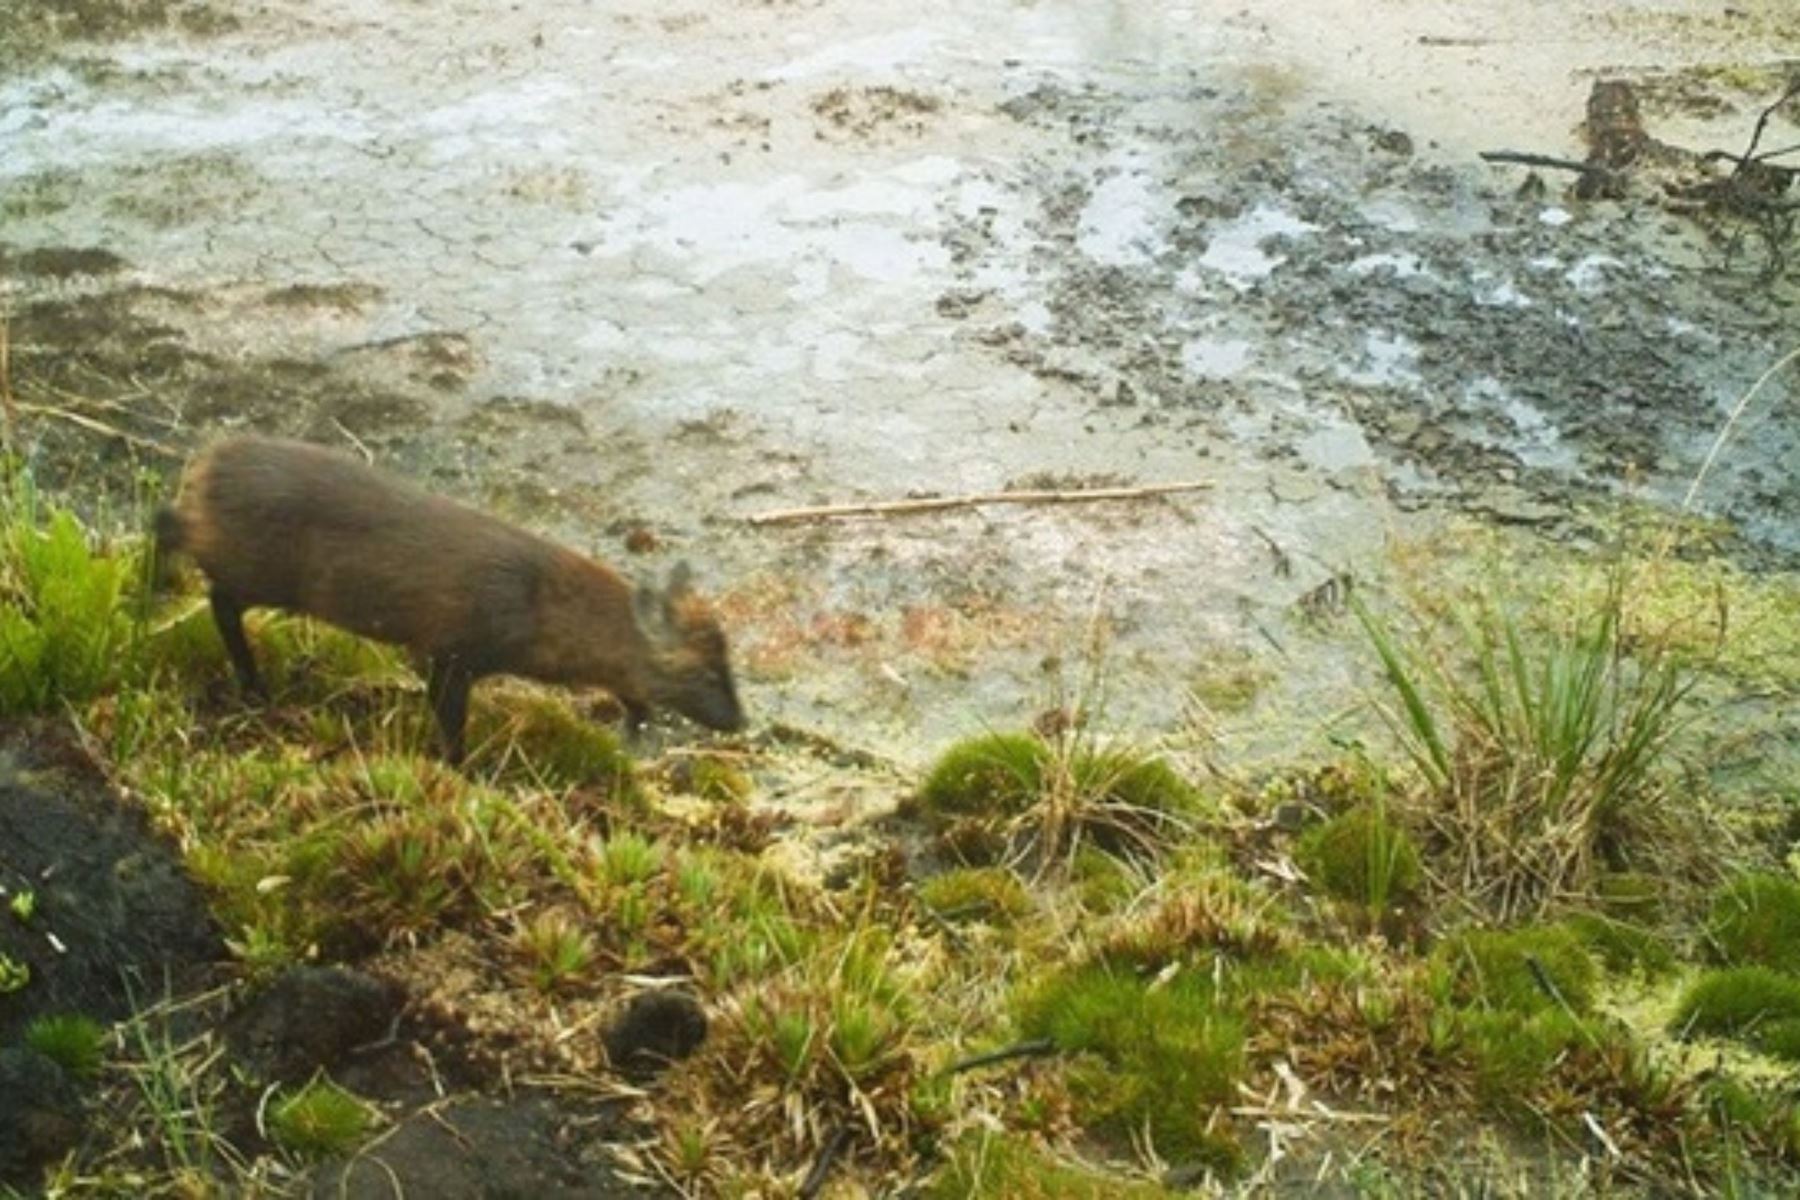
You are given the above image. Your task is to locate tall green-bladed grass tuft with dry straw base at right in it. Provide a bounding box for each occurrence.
[1352,572,1694,919]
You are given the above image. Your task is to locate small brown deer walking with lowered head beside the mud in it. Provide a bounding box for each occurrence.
[155,437,743,763]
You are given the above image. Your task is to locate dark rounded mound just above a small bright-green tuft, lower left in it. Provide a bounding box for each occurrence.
[225,966,405,1083]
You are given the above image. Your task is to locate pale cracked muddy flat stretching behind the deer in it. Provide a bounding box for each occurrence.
[0,0,1800,1195]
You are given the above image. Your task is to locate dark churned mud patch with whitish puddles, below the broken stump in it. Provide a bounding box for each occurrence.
[938,83,1800,560]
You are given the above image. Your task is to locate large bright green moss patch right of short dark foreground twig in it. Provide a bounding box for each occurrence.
[1019,966,1244,1168]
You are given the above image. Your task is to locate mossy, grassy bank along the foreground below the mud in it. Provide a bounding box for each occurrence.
[10,471,1800,1198]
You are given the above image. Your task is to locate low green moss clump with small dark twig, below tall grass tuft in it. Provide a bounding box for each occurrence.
[1435,925,1598,1015]
